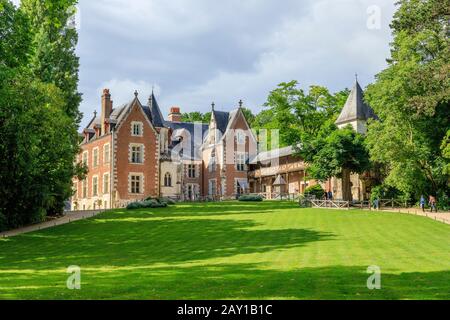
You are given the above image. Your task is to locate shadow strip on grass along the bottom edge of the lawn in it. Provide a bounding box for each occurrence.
[0,264,450,300]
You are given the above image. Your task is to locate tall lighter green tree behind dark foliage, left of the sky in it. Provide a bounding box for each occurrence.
[21,0,81,123]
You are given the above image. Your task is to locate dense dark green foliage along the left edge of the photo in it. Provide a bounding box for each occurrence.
[0,0,85,229]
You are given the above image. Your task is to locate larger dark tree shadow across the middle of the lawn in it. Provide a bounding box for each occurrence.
[0,212,334,270]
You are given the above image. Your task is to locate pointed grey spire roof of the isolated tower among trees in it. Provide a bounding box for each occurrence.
[336,80,377,125]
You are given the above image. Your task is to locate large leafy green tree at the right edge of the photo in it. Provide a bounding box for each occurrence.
[366,0,450,198]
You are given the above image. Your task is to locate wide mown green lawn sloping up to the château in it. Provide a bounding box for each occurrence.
[0,202,450,299]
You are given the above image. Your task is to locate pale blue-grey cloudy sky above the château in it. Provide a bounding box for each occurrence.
[13,0,395,125]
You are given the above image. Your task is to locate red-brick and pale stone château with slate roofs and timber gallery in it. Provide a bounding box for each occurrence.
[71,82,375,210]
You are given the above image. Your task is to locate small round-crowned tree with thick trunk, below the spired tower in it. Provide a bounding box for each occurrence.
[299,123,370,201]
